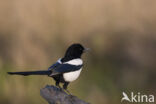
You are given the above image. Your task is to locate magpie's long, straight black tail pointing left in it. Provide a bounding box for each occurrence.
[8,70,52,76]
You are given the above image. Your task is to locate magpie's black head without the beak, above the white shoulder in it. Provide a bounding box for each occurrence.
[63,44,85,61]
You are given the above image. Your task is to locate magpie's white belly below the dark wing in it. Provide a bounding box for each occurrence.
[63,68,82,82]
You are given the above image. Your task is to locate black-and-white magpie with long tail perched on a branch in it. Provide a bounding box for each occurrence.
[8,43,89,94]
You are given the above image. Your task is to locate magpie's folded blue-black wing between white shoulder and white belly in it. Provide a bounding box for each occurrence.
[52,64,83,75]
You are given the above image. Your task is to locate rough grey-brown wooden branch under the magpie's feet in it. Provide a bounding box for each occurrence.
[40,85,89,104]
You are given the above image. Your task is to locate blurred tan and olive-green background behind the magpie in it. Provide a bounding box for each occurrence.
[0,0,156,104]
